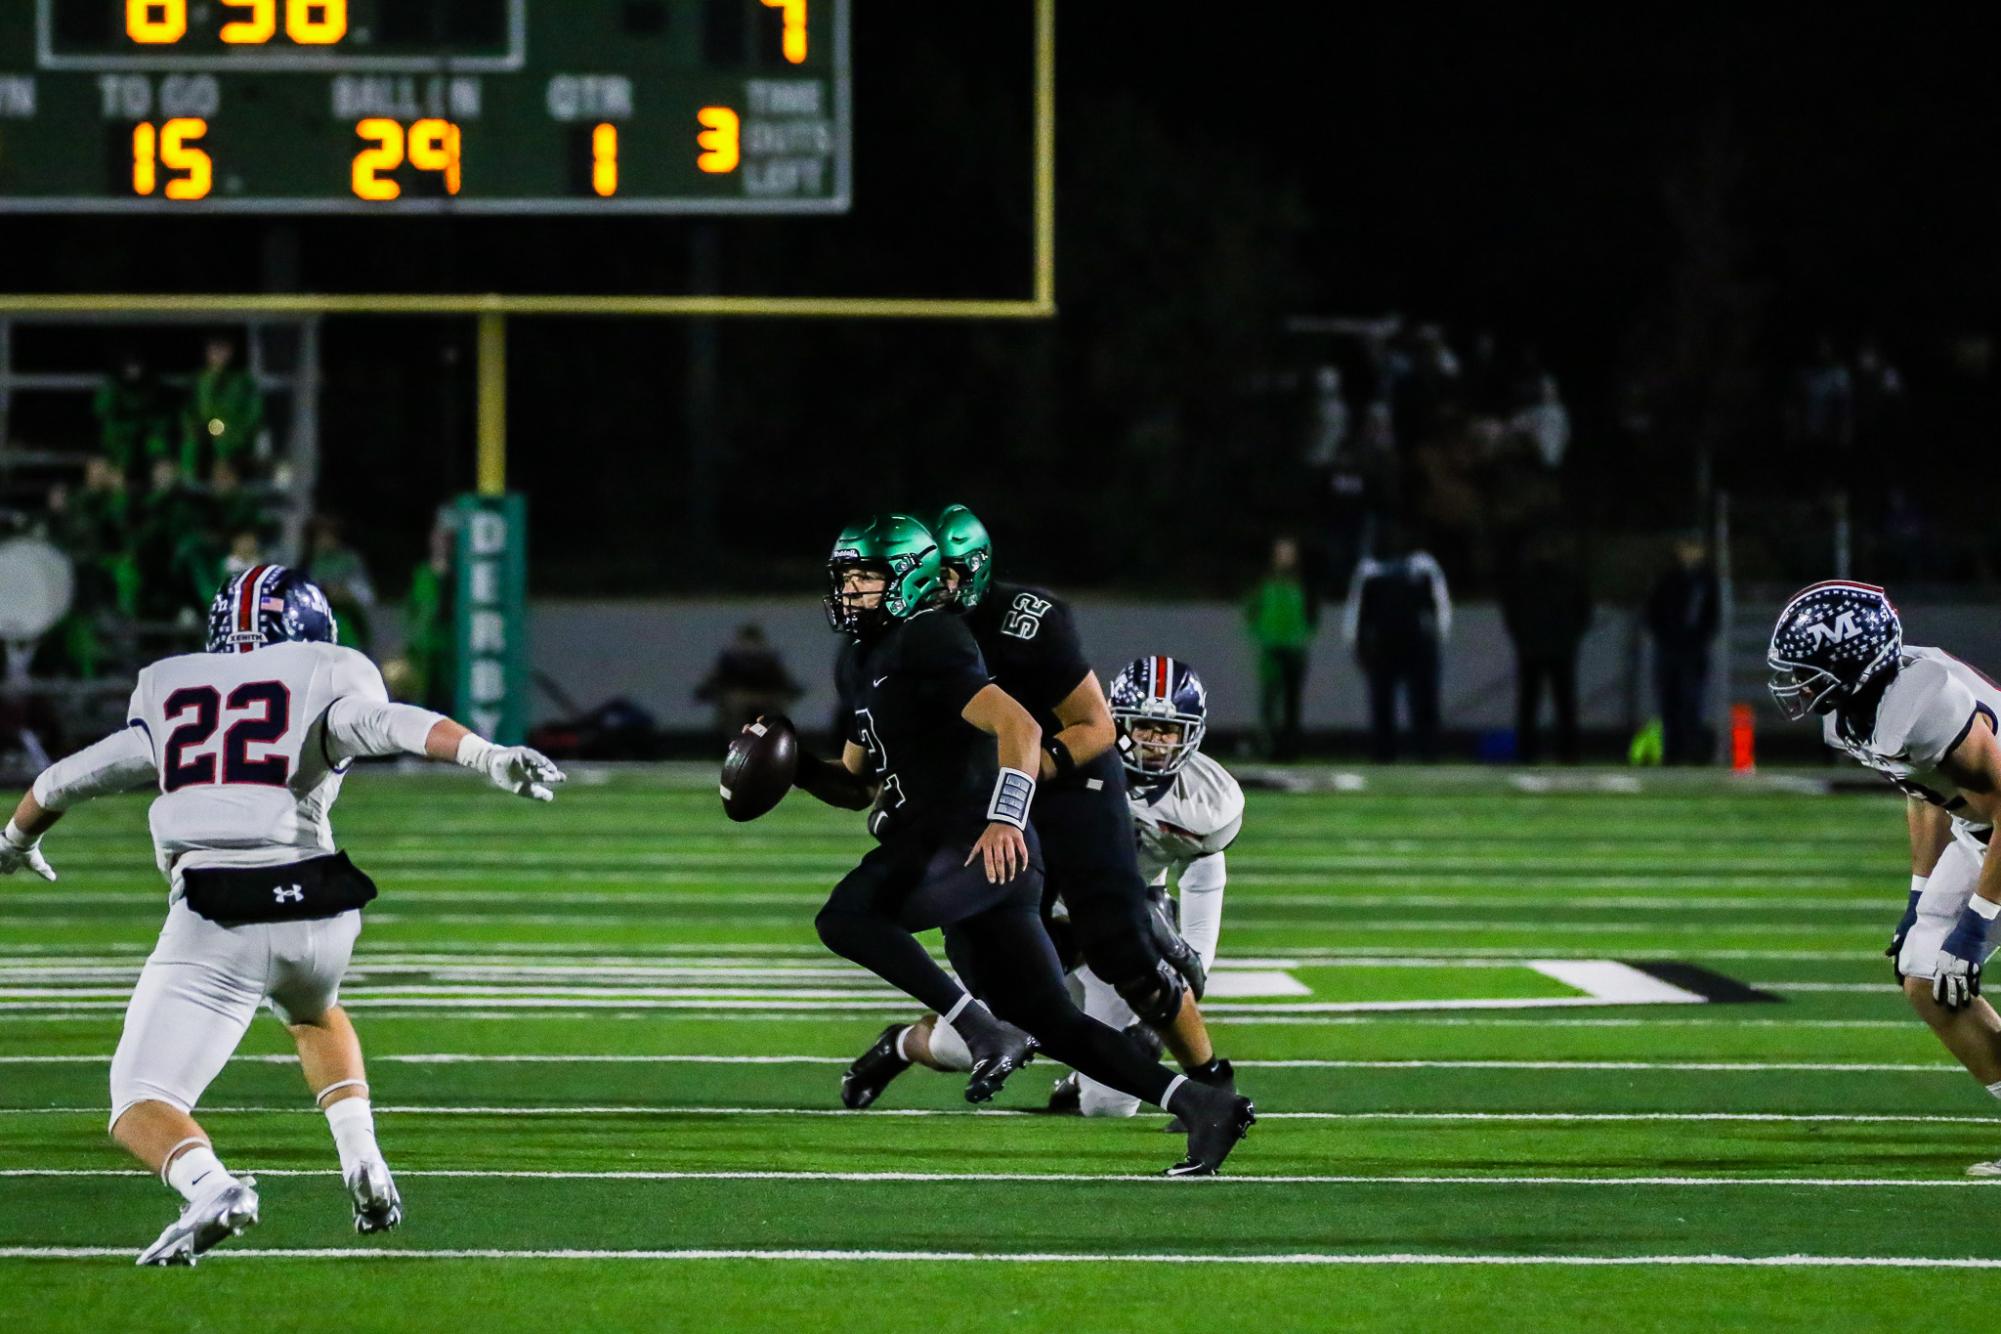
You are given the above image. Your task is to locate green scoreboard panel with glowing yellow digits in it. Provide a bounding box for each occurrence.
[0,0,852,214]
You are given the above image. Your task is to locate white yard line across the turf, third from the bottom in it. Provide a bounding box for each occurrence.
[0,1102,2001,1130]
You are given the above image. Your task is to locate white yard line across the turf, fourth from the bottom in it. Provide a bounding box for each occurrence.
[0,1052,1965,1074]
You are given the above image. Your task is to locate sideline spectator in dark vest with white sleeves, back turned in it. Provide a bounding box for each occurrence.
[1343,524,1453,764]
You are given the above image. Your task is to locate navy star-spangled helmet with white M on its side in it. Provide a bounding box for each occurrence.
[1765,580,1903,718]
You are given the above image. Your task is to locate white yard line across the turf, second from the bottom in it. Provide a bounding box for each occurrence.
[0,1168,2001,1190]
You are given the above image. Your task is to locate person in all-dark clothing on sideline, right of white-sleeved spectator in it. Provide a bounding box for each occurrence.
[1501,532,1591,764]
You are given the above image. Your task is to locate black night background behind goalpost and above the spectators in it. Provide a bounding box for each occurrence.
[0,0,1997,592]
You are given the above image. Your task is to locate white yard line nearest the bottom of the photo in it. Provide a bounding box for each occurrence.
[0,1248,2001,1270]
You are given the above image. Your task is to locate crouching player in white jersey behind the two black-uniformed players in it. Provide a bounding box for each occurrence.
[1051,656,1245,1116]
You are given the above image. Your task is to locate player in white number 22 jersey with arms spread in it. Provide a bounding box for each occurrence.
[0,566,562,1264]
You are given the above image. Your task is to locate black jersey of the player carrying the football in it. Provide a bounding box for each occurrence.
[834,610,1001,840]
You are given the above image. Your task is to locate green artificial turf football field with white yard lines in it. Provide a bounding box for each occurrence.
[0,770,2001,1332]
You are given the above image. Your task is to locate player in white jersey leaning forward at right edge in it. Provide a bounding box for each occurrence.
[1767,580,2001,1176]
